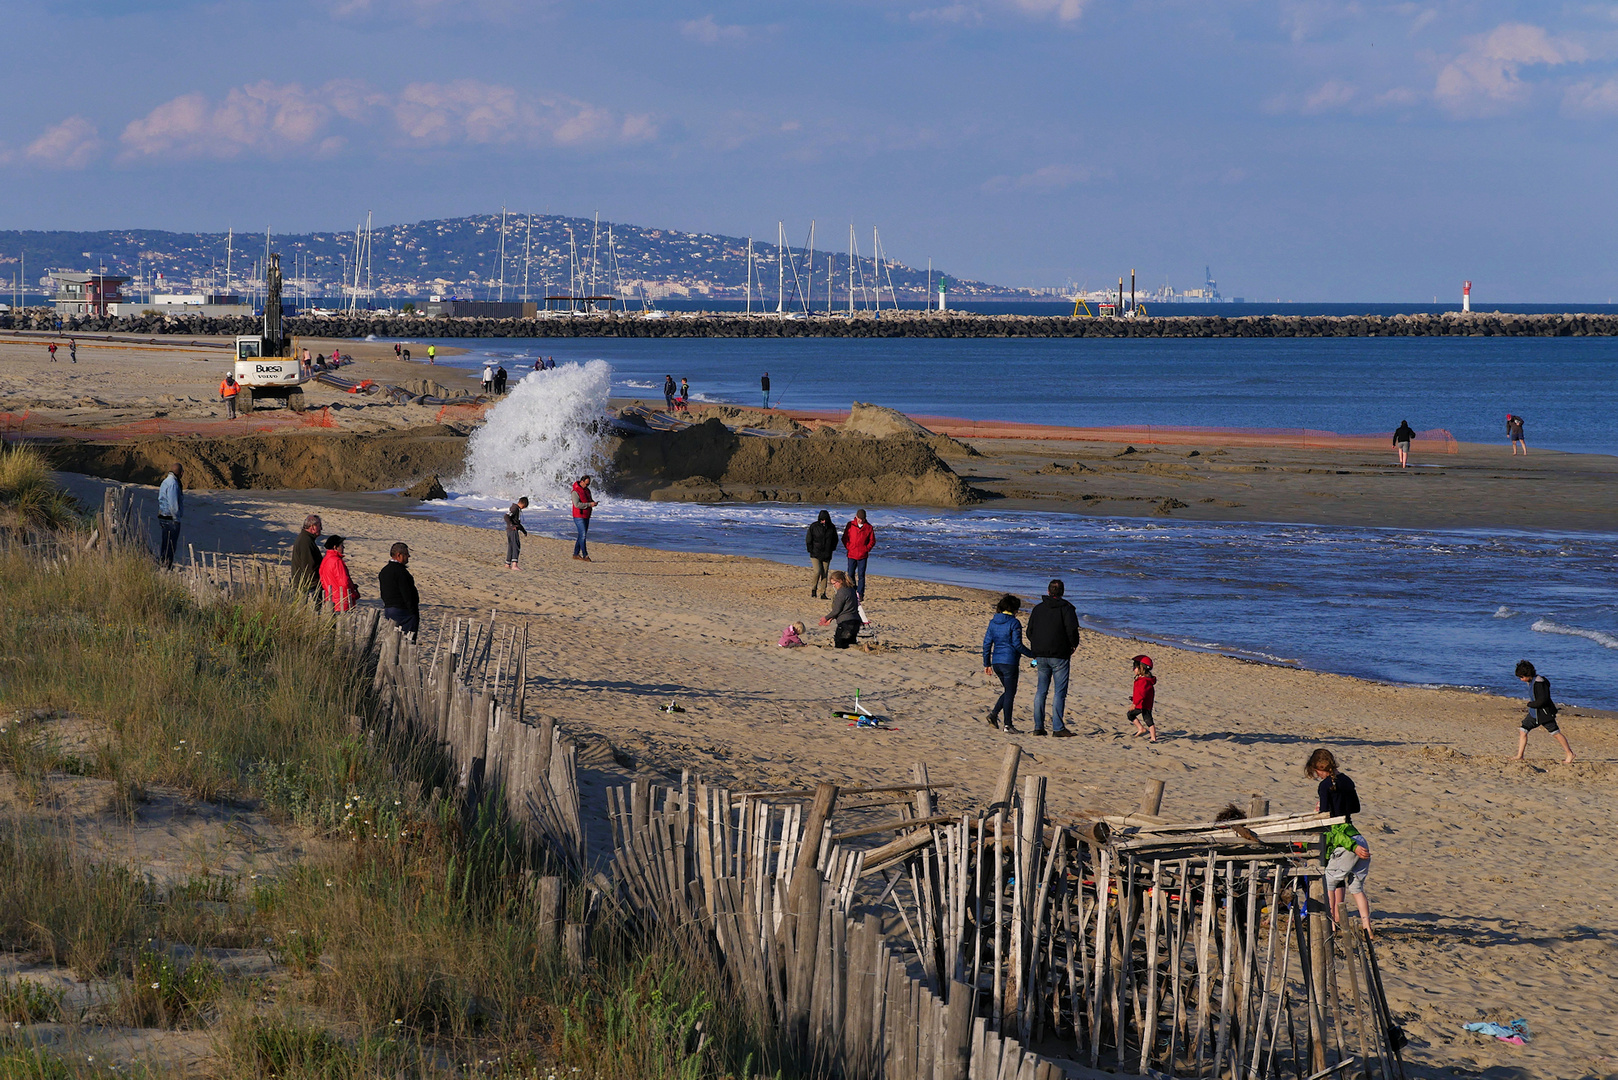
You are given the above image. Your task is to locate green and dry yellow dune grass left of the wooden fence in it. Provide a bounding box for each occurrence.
[0,531,780,1080]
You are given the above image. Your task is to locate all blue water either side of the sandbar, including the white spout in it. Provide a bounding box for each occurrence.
[391,338,1618,709]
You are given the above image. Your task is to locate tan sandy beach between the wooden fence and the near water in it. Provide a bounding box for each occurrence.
[47,466,1618,1077]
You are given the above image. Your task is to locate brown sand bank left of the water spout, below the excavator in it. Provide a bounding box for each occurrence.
[49,426,466,491]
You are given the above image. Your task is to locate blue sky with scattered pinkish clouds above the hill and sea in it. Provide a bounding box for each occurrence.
[0,0,1618,299]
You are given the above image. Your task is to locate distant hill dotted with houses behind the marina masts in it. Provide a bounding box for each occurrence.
[0,214,1029,309]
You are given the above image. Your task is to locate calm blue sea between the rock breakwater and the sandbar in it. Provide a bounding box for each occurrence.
[427,338,1618,453]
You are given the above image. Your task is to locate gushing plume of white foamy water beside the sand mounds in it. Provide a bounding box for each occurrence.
[455,359,612,505]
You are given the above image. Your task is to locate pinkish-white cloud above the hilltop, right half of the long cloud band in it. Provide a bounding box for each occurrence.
[393,79,657,146]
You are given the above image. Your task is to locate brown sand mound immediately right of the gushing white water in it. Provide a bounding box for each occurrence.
[613,416,977,507]
